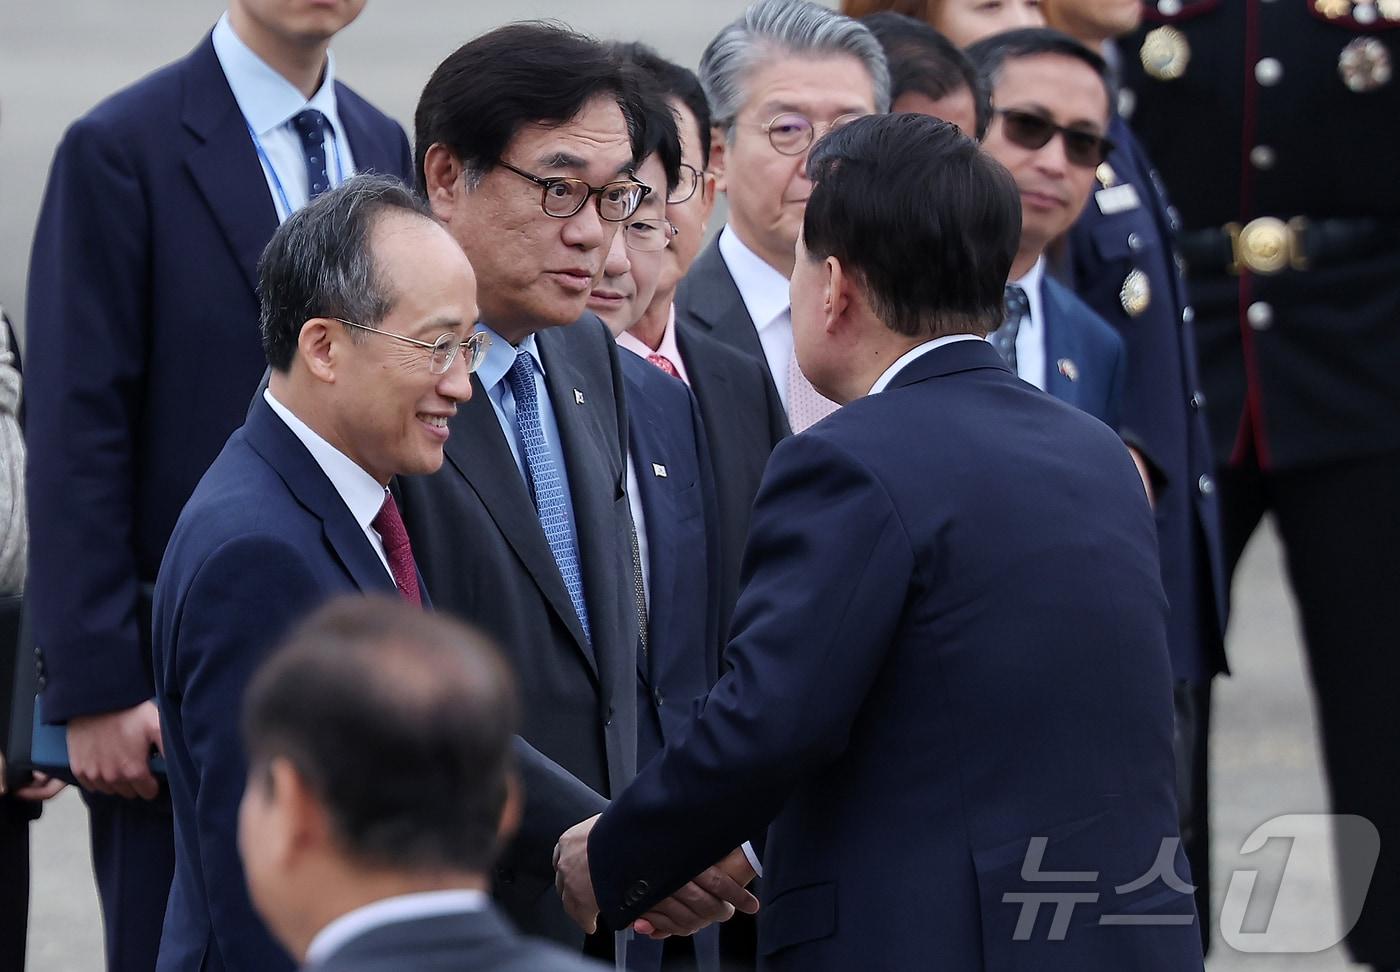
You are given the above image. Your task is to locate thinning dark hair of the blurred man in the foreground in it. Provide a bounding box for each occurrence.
[242,597,519,873]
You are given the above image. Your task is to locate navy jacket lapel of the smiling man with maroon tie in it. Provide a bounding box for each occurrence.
[244,399,397,592]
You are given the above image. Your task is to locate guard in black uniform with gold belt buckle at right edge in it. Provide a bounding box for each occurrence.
[1120,0,1400,968]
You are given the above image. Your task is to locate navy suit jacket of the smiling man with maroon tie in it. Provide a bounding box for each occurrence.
[153,401,403,972]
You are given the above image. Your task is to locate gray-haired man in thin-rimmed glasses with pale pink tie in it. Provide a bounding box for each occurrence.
[676,0,889,431]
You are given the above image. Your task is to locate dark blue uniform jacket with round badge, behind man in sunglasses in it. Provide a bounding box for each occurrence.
[1070,118,1228,681]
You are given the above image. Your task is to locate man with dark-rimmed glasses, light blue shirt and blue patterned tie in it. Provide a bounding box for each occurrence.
[402,24,753,969]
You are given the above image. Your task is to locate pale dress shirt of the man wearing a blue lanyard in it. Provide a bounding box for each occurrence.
[213,13,354,220]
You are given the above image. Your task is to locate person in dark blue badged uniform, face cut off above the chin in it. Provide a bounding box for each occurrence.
[1044,0,1226,945]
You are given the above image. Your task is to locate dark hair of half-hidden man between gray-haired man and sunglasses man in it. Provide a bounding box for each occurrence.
[861,11,991,139]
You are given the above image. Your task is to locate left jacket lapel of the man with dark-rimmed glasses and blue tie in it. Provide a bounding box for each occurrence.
[434,375,598,675]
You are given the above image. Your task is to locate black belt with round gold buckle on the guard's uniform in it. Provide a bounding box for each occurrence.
[1177,216,1400,276]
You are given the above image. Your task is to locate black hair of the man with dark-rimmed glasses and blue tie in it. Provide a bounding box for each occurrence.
[413,21,643,193]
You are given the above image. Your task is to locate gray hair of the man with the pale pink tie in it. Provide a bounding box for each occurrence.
[700,0,889,136]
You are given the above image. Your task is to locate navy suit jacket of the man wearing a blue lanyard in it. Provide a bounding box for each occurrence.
[25,36,412,721]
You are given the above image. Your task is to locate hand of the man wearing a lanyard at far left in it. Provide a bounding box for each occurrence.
[69,702,165,800]
